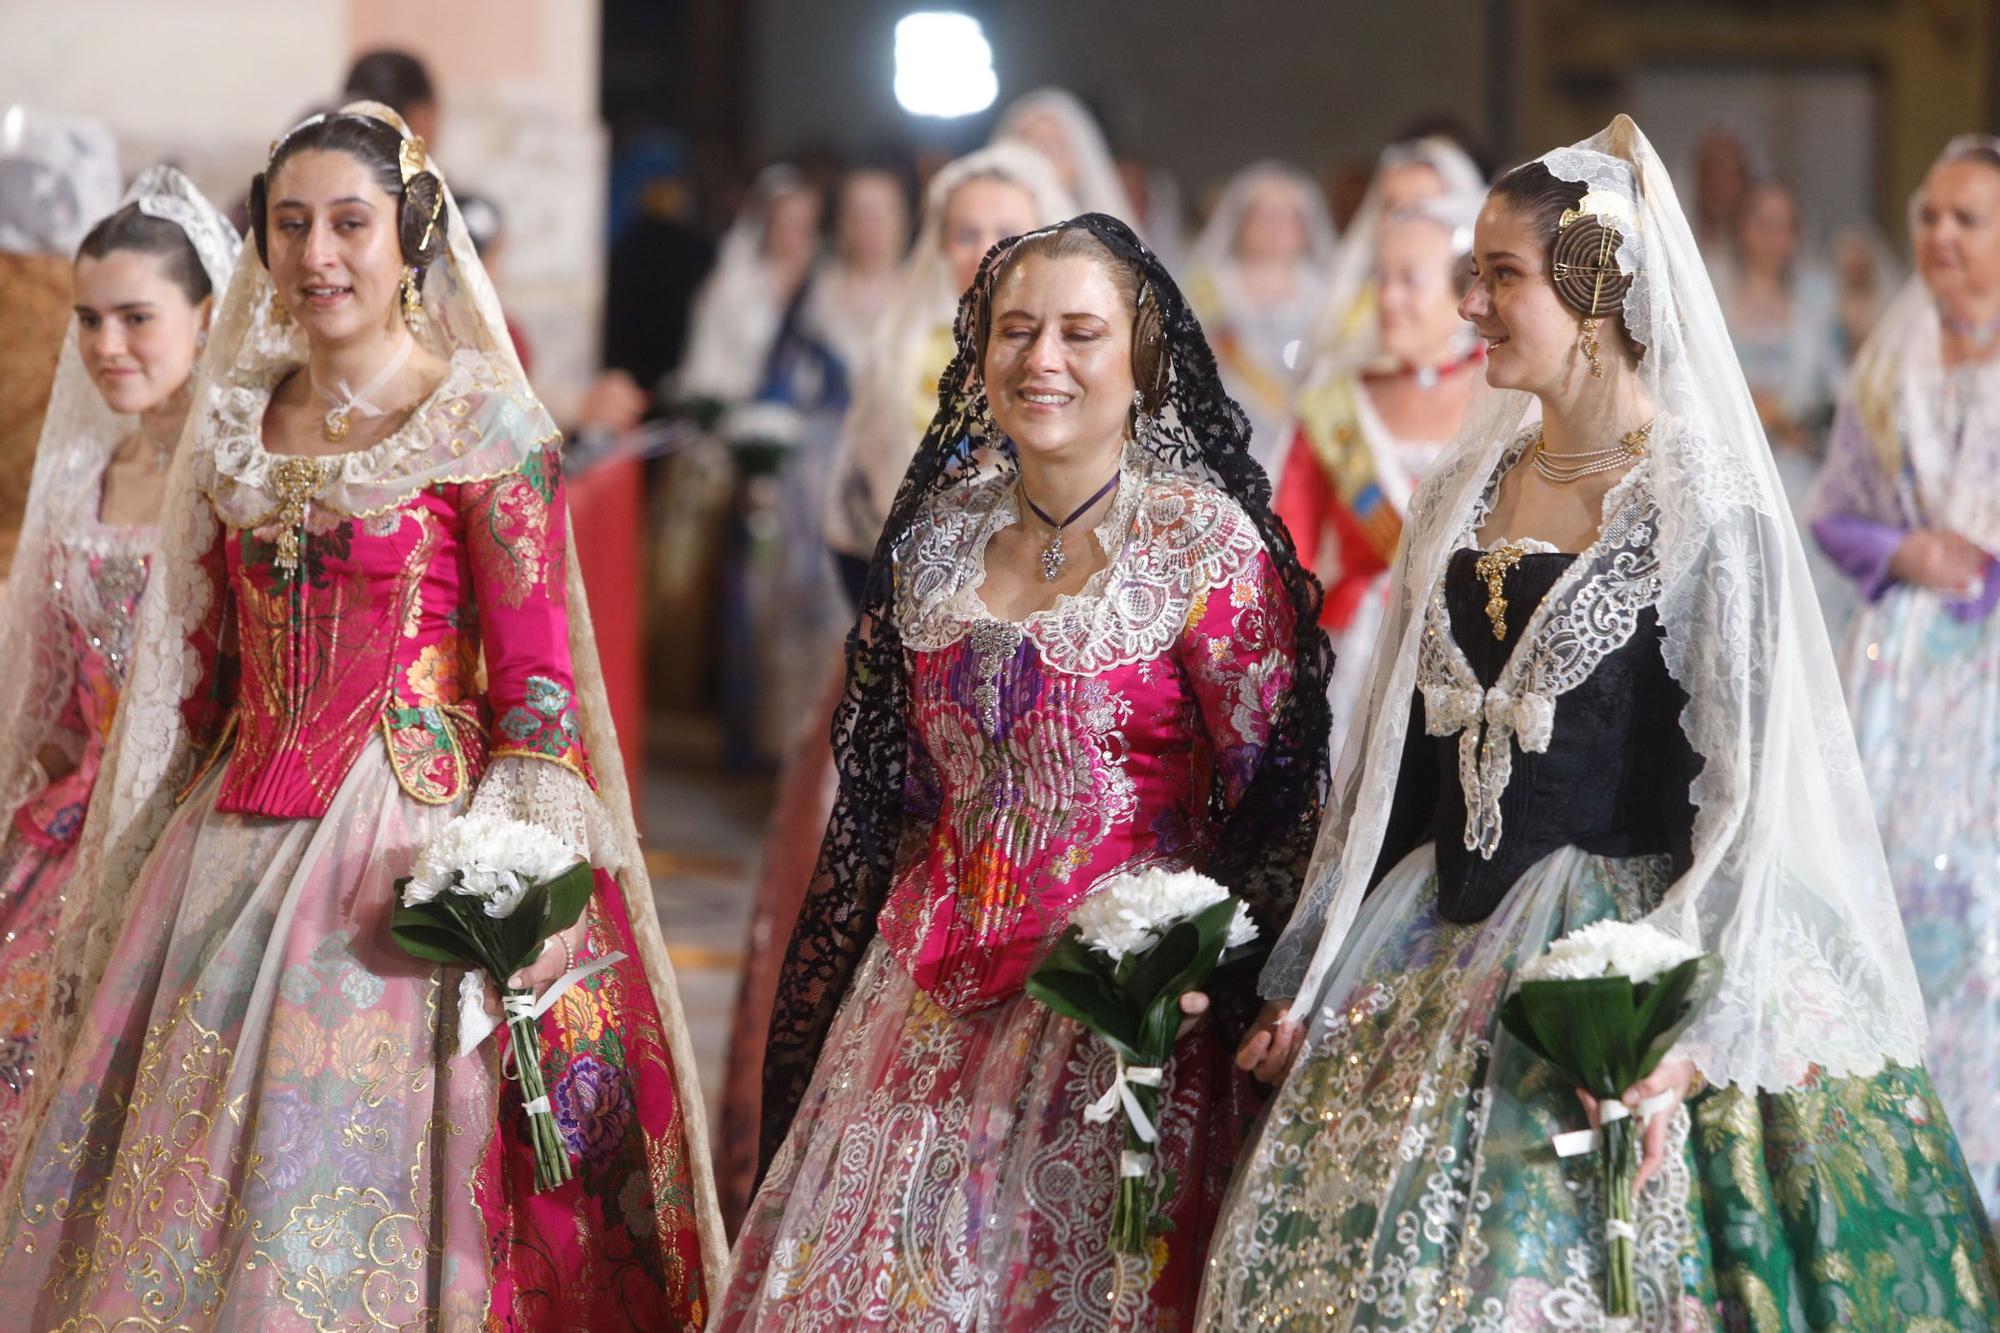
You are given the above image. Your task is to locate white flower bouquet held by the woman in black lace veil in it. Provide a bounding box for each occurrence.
[1028,871,1256,1255]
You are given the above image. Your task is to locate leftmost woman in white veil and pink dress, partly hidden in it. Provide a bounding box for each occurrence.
[0,166,238,1185]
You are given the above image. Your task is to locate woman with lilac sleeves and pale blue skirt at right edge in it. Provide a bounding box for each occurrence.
[1812,134,2000,1217]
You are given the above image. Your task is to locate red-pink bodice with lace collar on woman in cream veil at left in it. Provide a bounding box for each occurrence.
[184,352,590,817]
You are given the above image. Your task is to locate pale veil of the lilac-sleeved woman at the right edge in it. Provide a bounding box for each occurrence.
[1808,134,2000,554]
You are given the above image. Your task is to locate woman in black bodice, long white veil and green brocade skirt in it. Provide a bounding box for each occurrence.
[1200,116,2000,1331]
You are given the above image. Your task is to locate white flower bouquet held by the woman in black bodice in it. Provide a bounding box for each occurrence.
[1500,921,1722,1319]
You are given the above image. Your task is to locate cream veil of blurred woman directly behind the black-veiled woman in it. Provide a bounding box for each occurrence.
[826,140,1076,558]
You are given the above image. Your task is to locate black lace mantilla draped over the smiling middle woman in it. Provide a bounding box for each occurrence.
[762,212,1334,1167]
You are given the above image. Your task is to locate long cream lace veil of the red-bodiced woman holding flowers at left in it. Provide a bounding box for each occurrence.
[14,102,726,1291]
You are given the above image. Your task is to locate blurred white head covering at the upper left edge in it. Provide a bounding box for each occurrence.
[0,102,118,256]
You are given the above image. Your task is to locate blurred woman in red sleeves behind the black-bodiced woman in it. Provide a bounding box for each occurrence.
[1274,190,1486,751]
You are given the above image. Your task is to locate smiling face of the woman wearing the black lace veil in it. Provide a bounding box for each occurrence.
[984,254,1134,458]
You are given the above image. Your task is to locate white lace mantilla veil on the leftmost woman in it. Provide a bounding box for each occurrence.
[0,166,238,821]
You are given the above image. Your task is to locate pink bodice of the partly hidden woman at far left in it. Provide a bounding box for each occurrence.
[14,522,154,851]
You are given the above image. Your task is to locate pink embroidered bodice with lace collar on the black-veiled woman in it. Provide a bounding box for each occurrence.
[880,450,1294,1013]
